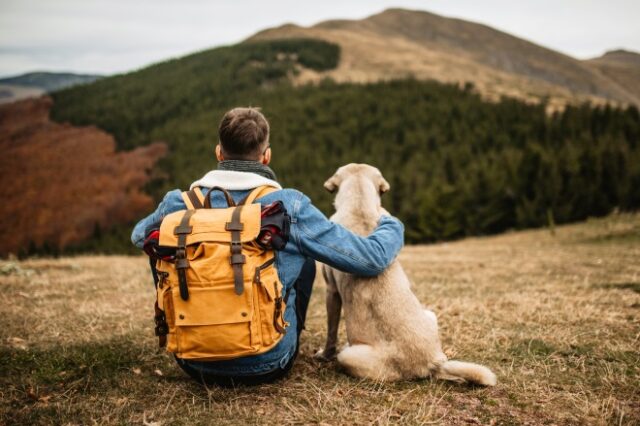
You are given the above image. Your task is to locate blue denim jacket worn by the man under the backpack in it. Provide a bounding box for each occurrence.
[131,185,404,376]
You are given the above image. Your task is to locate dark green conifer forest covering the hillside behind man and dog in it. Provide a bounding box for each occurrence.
[42,39,640,251]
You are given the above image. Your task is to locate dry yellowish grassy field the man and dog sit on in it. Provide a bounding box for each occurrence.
[0,215,640,426]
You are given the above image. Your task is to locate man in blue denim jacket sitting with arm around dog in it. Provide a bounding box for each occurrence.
[131,108,404,386]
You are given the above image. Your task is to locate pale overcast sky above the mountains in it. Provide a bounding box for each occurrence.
[0,0,640,76]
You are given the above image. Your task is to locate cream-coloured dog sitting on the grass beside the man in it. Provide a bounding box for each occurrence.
[316,164,496,386]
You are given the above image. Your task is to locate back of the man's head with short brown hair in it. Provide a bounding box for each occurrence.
[218,107,269,160]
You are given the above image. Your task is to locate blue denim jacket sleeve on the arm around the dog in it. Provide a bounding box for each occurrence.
[291,193,404,276]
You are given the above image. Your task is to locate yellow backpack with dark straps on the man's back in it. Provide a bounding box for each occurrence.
[156,186,289,361]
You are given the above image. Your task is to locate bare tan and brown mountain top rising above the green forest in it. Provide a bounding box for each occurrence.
[248,9,640,106]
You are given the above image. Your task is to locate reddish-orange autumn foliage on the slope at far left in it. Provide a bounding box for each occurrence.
[0,97,167,255]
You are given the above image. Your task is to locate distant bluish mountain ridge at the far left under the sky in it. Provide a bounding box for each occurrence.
[0,72,102,103]
